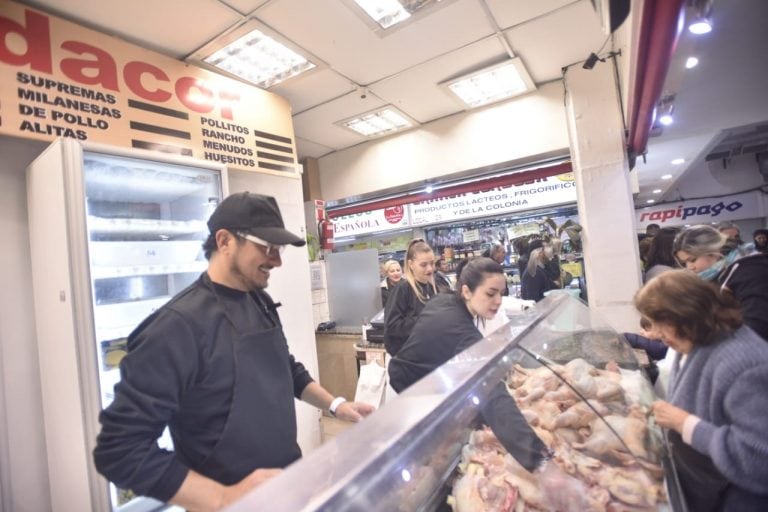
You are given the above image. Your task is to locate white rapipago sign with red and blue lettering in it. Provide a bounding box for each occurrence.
[636,191,765,230]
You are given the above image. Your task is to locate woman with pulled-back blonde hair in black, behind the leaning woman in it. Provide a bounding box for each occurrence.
[384,238,437,356]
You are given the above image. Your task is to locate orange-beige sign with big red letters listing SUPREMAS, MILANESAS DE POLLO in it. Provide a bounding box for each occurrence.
[0,0,297,173]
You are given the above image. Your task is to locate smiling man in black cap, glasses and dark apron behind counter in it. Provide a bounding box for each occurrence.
[94,192,373,510]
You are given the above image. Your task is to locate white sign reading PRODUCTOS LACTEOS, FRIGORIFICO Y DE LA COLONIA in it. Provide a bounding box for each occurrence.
[409,173,576,226]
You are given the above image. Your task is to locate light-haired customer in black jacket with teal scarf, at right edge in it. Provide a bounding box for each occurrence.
[672,224,768,340]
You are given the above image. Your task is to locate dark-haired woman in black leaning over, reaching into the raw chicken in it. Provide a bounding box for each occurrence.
[389,257,586,510]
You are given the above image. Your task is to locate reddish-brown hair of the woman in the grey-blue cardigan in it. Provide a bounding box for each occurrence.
[635,270,743,345]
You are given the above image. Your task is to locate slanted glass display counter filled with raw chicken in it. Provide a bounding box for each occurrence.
[227,294,685,512]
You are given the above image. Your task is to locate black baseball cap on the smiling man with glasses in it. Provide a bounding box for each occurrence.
[208,192,307,247]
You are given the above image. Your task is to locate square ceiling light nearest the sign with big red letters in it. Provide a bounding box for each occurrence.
[203,29,315,89]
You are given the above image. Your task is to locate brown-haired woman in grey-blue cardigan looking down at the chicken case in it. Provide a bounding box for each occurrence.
[635,270,768,512]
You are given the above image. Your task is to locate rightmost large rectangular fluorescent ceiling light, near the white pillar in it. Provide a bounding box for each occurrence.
[440,57,536,108]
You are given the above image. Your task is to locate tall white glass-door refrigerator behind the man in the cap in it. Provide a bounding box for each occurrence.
[27,139,227,512]
